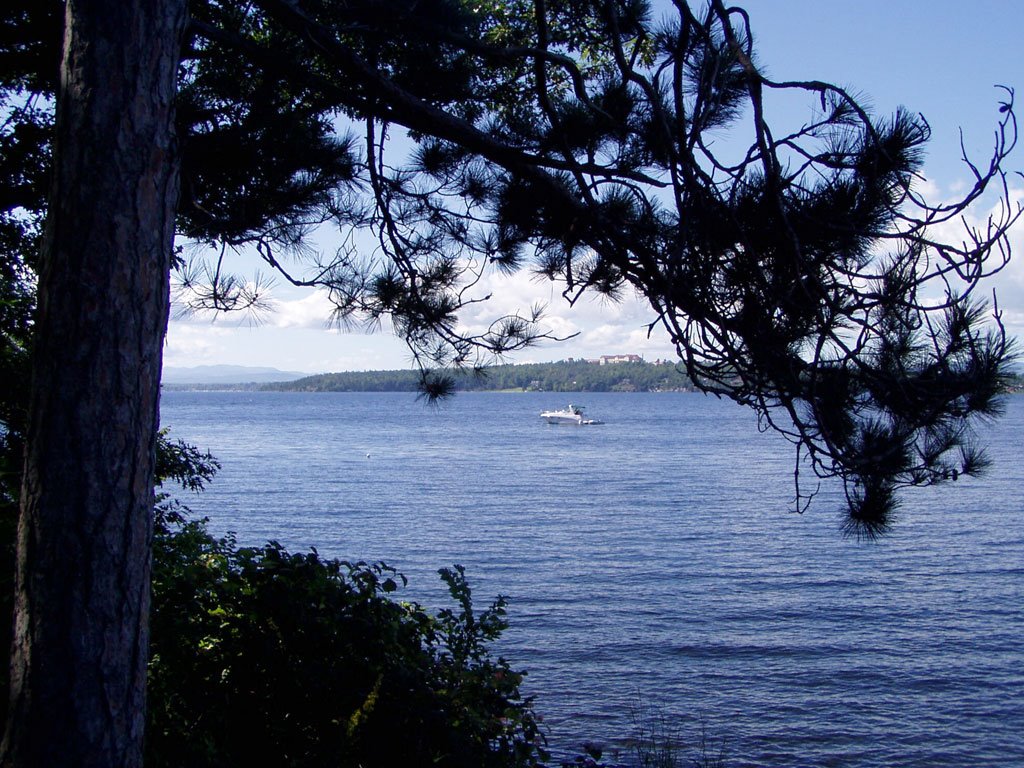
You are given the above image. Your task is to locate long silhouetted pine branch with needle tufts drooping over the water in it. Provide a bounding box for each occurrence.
[176,0,1020,535]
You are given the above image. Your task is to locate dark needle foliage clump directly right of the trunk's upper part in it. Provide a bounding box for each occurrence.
[177,2,354,252]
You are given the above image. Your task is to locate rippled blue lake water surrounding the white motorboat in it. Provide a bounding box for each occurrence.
[162,392,1024,768]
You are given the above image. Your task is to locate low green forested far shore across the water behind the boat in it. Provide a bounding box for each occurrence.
[256,360,693,392]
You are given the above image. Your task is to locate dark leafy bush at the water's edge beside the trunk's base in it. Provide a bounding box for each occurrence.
[146,504,543,768]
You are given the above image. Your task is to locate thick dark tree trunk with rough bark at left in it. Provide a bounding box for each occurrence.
[2,0,185,768]
